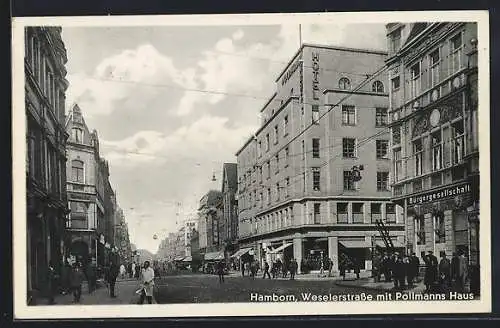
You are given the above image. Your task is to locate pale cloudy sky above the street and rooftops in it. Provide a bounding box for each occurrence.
[62,24,386,253]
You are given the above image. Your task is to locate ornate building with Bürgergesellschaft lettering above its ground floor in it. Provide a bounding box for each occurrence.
[387,23,479,276]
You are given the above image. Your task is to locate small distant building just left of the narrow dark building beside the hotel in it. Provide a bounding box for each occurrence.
[198,190,223,260]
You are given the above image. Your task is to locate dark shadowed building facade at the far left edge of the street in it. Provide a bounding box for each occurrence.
[24,27,68,291]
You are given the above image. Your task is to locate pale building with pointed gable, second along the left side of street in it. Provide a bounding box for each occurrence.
[66,105,114,265]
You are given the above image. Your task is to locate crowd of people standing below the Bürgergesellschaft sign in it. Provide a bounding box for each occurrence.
[372,251,468,293]
